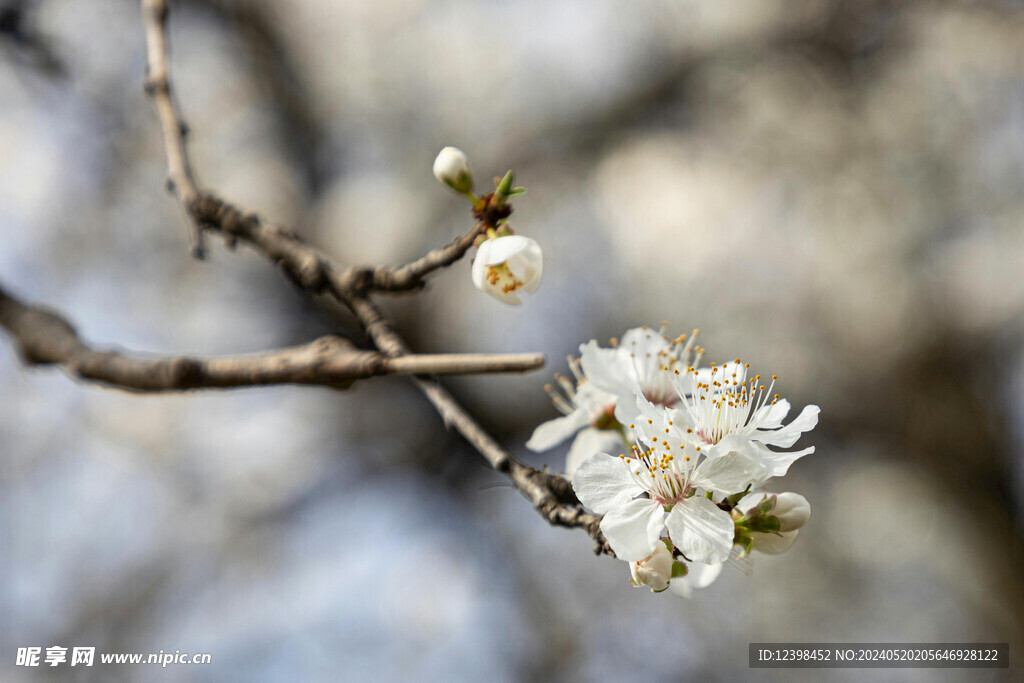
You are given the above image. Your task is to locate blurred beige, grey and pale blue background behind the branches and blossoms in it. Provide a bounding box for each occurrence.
[0,0,1024,681]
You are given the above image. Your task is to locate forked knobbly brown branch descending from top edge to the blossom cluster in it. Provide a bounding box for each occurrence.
[142,0,613,556]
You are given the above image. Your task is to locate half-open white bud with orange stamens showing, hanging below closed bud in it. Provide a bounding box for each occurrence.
[472,234,544,305]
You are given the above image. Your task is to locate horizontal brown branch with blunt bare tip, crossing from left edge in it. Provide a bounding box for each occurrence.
[0,288,544,392]
